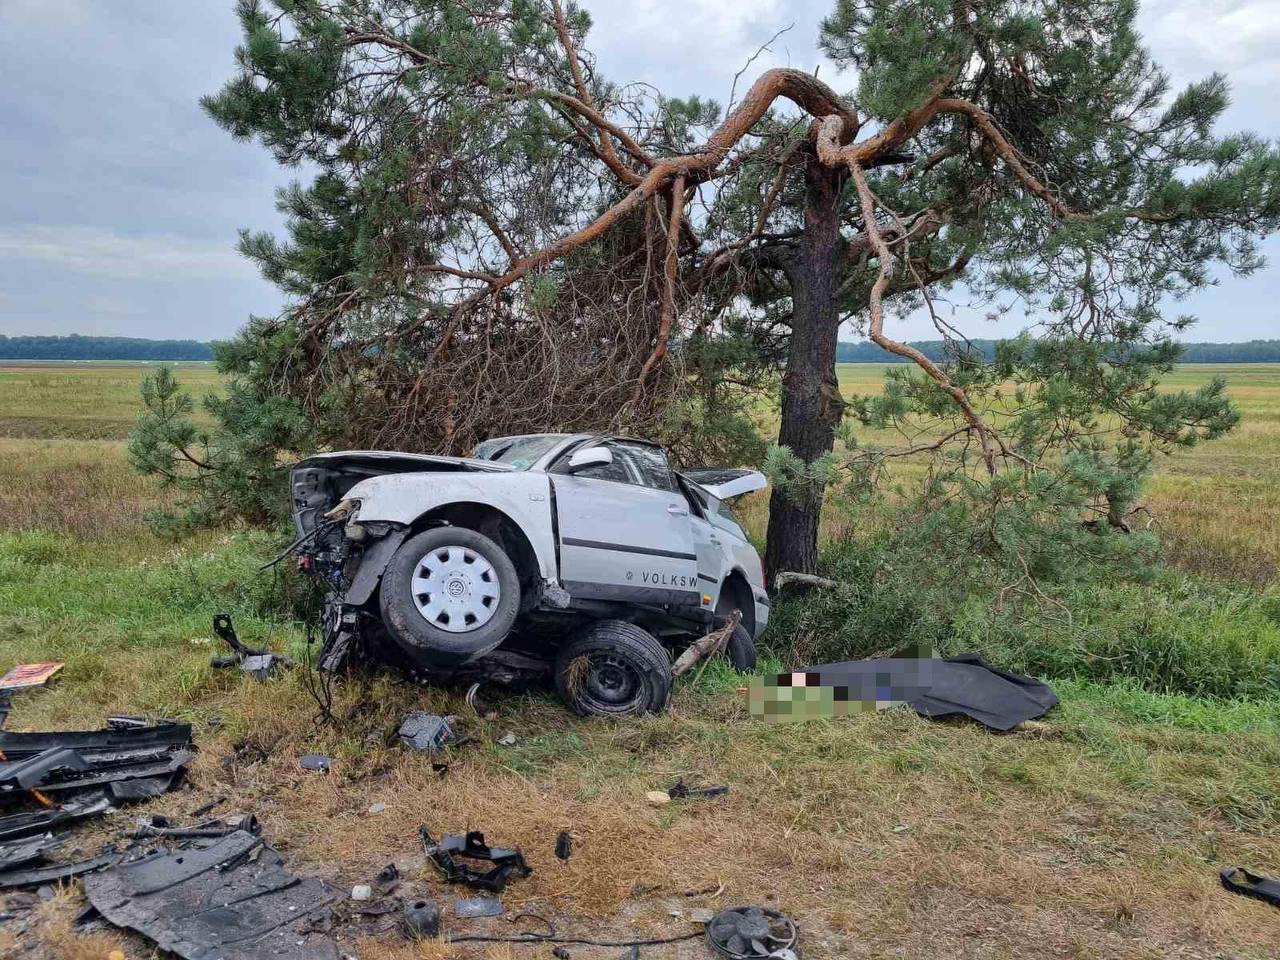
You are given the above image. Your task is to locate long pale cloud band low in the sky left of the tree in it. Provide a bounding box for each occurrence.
[0,224,252,280]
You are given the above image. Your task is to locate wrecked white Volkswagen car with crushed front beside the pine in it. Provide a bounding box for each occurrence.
[291,434,769,713]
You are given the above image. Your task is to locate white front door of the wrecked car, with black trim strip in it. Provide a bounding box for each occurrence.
[550,440,703,607]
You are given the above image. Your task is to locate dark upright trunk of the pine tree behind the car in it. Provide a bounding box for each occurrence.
[764,156,844,582]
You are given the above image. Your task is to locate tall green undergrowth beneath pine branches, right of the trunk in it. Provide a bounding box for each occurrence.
[763,535,1280,698]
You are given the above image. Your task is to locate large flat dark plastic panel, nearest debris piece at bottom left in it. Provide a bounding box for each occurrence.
[84,831,340,960]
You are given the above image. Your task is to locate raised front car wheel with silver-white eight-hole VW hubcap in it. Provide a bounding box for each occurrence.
[379,526,520,669]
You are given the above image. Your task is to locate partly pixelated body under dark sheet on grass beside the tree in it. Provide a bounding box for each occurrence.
[748,653,1057,732]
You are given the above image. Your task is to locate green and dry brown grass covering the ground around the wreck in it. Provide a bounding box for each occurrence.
[0,367,1280,960]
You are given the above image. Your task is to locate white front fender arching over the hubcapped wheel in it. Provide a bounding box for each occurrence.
[347,471,558,581]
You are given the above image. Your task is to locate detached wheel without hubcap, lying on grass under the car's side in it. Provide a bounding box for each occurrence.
[556,620,671,717]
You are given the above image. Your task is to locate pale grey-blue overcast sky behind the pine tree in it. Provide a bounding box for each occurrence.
[0,0,1280,340]
